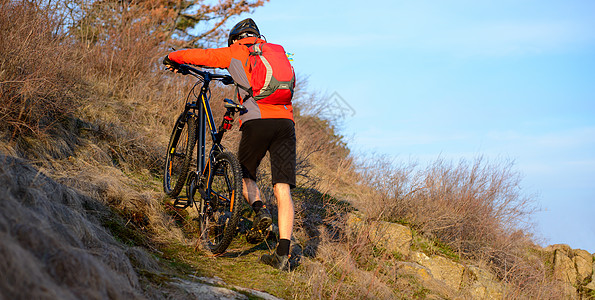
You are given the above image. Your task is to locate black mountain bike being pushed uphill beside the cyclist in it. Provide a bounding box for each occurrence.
[163,65,247,254]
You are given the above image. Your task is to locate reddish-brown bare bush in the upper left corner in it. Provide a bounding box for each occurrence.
[0,1,84,138]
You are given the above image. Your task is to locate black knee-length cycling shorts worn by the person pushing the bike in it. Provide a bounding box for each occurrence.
[238,119,296,188]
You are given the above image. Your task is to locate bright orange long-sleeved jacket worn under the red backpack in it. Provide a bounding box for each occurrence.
[168,37,293,122]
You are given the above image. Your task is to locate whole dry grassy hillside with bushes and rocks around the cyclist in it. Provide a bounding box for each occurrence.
[0,1,595,299]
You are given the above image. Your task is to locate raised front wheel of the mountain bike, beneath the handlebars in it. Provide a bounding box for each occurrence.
[163,114,196,198]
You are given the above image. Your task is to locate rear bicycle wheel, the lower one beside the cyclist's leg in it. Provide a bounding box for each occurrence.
[198,152,243,254]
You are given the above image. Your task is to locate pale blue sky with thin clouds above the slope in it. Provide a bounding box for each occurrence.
[230,0,595,253]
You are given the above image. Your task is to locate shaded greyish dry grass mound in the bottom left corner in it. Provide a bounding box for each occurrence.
[0,156,147,299]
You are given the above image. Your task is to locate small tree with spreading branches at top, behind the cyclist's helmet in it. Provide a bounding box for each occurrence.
[64,0,268,47]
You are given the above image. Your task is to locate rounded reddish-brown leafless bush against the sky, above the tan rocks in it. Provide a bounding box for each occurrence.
[358,158,535,258]
